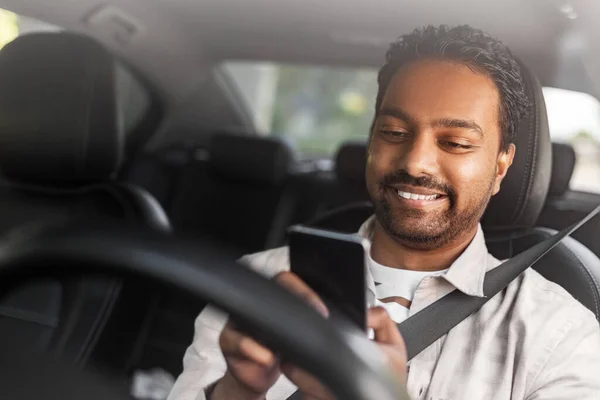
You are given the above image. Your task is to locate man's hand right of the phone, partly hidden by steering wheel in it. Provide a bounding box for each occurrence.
[281,307,407,400]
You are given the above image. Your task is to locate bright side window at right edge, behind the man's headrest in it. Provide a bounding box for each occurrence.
[543,87,600,193]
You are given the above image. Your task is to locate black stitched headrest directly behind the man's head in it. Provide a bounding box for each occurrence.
[482,64,552,232]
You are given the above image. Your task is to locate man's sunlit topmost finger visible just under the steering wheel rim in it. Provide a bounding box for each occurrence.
[219,324,277,367]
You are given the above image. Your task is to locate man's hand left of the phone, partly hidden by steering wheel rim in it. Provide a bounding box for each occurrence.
[211,272,328,400]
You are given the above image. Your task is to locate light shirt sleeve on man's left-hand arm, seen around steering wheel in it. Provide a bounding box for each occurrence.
[167,247,294,400]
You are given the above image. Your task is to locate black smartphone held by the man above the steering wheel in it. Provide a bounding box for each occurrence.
[288,225,369,332]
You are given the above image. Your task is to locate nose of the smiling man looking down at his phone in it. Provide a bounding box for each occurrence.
[400,133,439,177]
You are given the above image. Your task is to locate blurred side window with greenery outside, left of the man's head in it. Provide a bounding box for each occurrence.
[224,62,377,157]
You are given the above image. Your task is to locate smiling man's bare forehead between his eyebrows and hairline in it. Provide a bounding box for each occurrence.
[382,60,500,129]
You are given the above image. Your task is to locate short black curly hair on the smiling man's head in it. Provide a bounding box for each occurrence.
[375,25,529,151]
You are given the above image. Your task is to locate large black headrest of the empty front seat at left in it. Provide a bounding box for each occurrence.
[0,32,123,184]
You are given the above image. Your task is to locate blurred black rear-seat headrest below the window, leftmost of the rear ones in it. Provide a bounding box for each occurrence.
[208,133,294,185]
